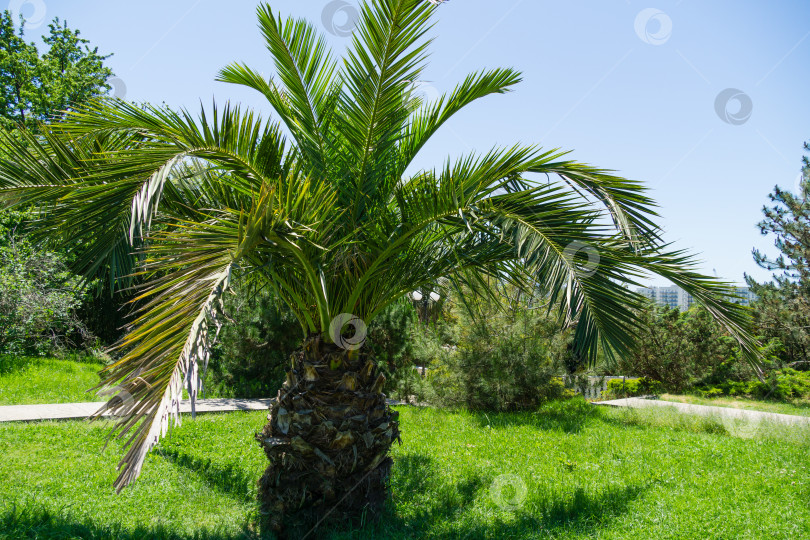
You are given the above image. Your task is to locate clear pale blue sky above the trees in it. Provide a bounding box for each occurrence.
[10,0,810,284]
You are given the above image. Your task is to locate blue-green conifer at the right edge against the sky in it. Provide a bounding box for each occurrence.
[746,143,810,369]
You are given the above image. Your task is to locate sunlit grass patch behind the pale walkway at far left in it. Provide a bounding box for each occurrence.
[0,355,104,405]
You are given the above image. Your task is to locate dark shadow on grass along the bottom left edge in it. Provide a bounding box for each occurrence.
[0,506,266,540]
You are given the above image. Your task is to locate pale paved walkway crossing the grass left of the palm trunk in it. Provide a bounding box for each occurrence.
[0,399,270,422]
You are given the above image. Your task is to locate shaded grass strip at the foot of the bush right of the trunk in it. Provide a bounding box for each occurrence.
[472,397,601,433]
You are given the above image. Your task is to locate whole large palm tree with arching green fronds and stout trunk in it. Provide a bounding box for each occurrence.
[0,0,756,528]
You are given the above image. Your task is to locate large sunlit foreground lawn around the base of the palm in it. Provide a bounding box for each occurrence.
[0,399,810,539]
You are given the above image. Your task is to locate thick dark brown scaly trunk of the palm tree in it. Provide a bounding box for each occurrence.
[256,334,401,531]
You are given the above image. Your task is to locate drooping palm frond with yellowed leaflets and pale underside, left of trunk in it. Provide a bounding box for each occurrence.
[96,178,330,491]
